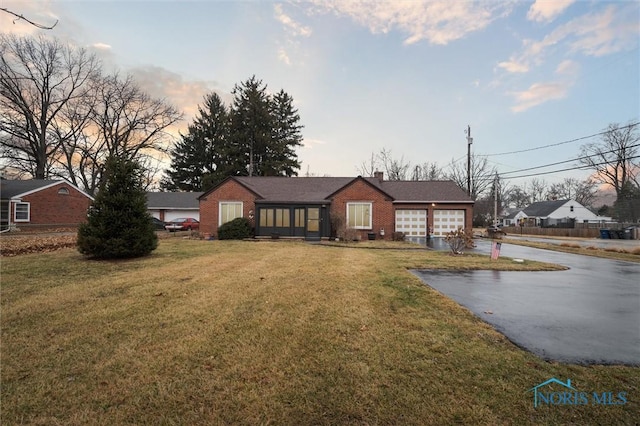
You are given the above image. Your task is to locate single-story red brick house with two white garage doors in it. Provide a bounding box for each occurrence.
[199,172,473,240]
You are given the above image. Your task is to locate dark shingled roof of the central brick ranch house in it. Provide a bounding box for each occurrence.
[205,176,473,203]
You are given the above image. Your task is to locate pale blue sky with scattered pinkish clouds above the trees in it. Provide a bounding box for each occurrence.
[0,0,640,184]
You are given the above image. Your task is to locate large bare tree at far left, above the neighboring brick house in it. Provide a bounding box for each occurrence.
[0,34,100,179]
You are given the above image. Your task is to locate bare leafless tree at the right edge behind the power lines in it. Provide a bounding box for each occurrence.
[580,123,640,197]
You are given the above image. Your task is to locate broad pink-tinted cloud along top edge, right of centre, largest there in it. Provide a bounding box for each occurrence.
[302,0,513,45]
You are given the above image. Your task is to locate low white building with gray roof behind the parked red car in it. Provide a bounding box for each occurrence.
[147,192,203,222]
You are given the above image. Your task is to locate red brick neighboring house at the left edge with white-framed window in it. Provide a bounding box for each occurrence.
[0,179,93,229]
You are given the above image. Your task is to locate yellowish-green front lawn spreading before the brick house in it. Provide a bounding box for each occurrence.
[0,239,640,425]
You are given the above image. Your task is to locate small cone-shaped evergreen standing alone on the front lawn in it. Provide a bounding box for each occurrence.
[78,156,158,259]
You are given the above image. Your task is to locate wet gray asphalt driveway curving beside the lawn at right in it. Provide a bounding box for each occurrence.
[413,240,640,365]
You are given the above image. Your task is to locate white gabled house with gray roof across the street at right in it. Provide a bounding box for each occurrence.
[515,200,612,226]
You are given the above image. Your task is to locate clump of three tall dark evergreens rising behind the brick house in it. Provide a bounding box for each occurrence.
[161,76,303,191]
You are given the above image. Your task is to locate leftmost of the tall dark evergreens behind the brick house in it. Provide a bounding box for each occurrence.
[161,93,234,191]
